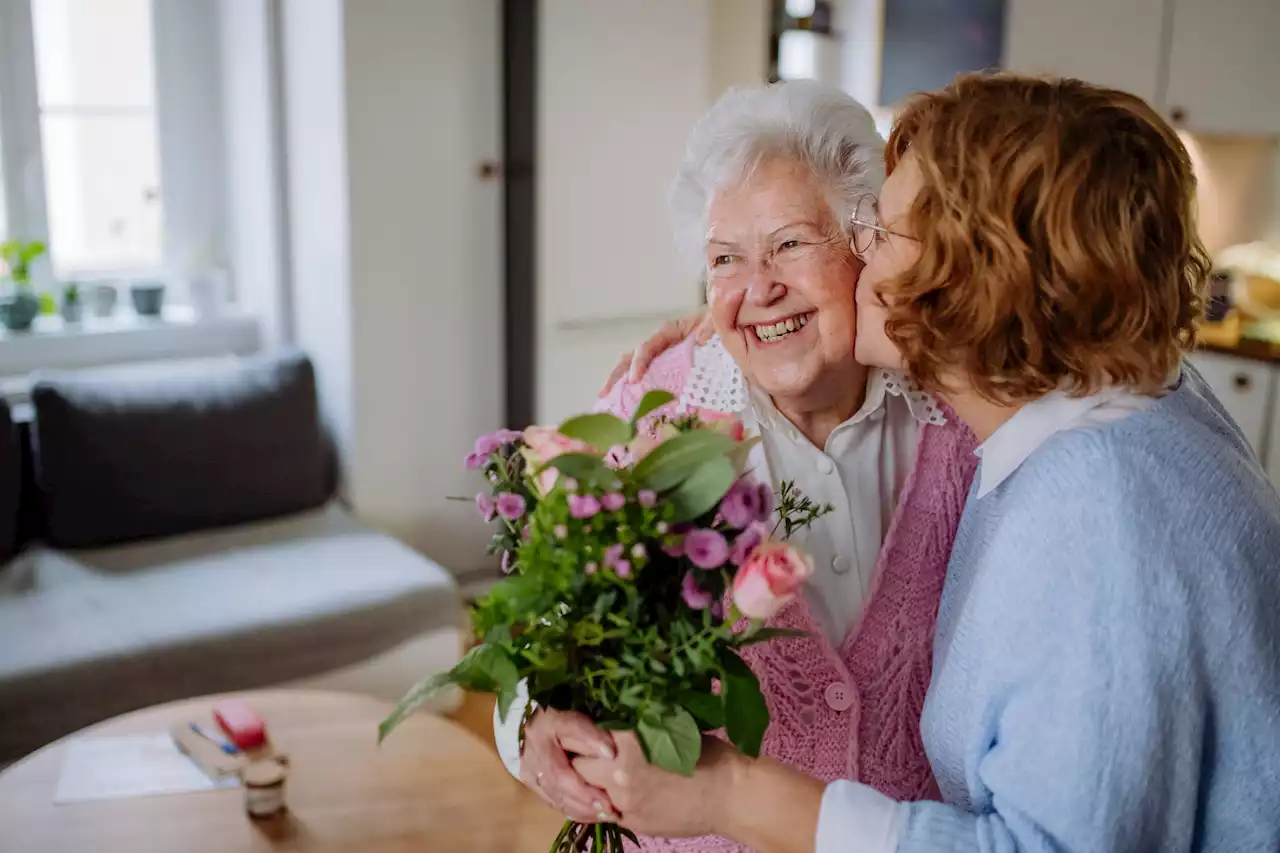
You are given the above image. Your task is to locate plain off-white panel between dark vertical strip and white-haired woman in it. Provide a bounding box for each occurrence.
[536,0,727,421]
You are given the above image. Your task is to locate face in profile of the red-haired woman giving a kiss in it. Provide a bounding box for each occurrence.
[854,154,922,370]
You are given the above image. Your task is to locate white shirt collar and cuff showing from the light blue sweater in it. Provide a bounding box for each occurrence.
[814,388,1156,853]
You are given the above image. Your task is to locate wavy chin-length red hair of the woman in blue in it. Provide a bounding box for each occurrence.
[882,74,1210,405]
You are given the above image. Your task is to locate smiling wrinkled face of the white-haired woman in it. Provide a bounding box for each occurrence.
[707,159,861,398]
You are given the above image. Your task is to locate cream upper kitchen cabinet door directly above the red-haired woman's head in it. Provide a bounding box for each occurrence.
[1004,0,1166,104]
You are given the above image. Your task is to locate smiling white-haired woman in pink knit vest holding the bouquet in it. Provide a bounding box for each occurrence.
[498,83,977,850]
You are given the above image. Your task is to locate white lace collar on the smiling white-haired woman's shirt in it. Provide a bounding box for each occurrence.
[680,336,947,427]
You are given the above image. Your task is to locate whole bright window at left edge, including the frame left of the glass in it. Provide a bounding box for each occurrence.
[0,0,165,286]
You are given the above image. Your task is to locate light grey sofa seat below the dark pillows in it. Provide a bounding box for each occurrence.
[0,506,460,765]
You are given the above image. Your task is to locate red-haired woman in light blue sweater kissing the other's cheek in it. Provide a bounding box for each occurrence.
[573,76,1280,853]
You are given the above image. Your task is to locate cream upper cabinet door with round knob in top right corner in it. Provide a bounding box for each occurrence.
[1162,0,1280,136]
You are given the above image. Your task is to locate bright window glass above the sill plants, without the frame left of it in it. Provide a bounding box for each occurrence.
[31,0,161,278]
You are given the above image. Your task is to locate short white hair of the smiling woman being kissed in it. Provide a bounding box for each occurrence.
[669,81,884,266]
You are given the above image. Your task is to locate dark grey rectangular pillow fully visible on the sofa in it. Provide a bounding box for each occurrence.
[31,353,332,548]
